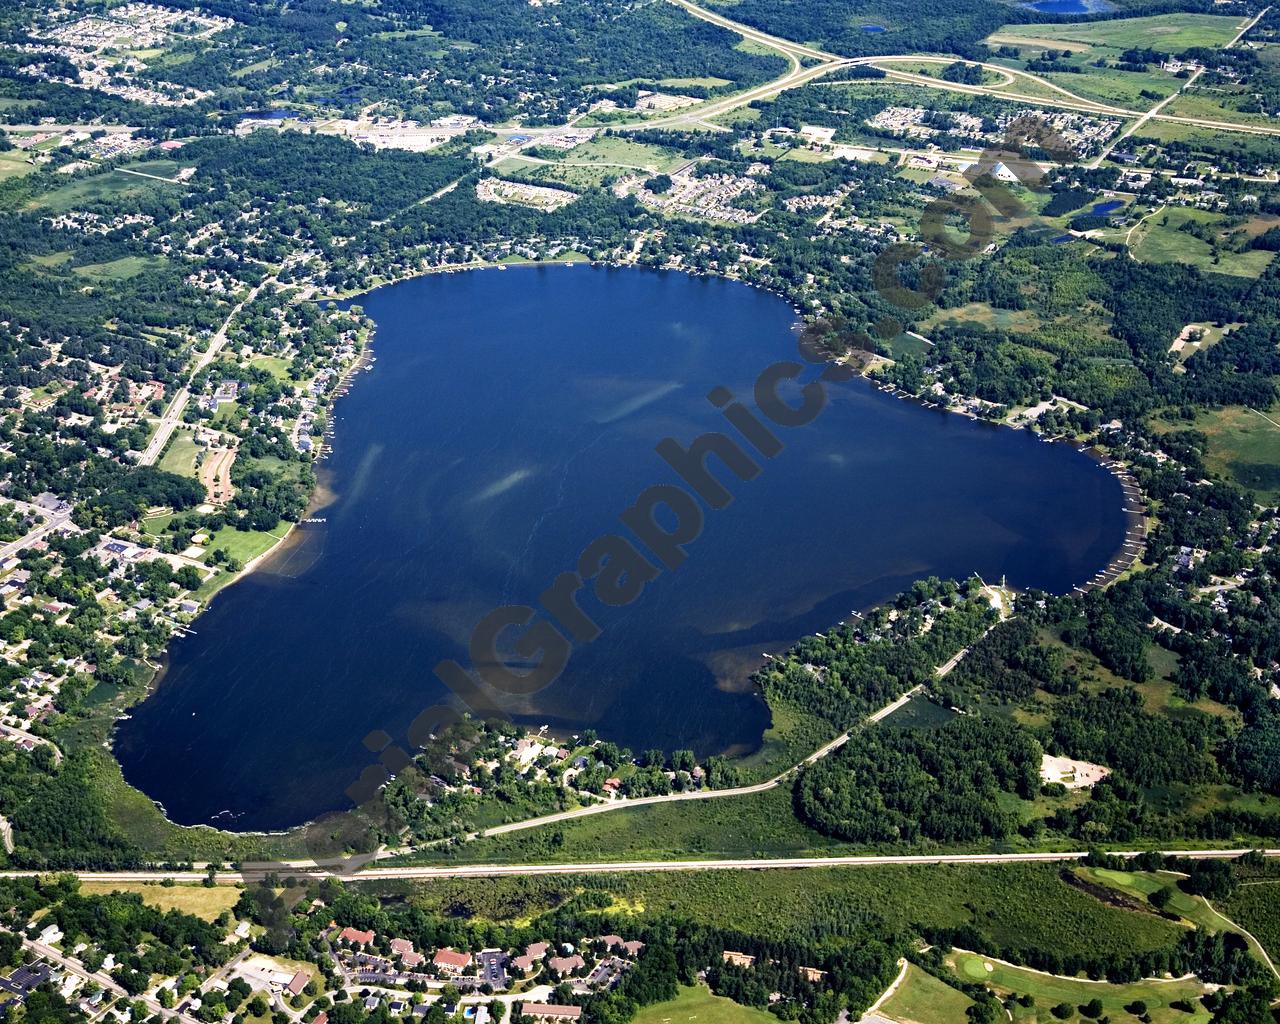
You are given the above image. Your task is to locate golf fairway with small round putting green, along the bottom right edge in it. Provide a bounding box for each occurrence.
[947,950,1210,1024]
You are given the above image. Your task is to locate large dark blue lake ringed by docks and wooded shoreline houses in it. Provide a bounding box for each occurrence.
[116,266,1124,829]
